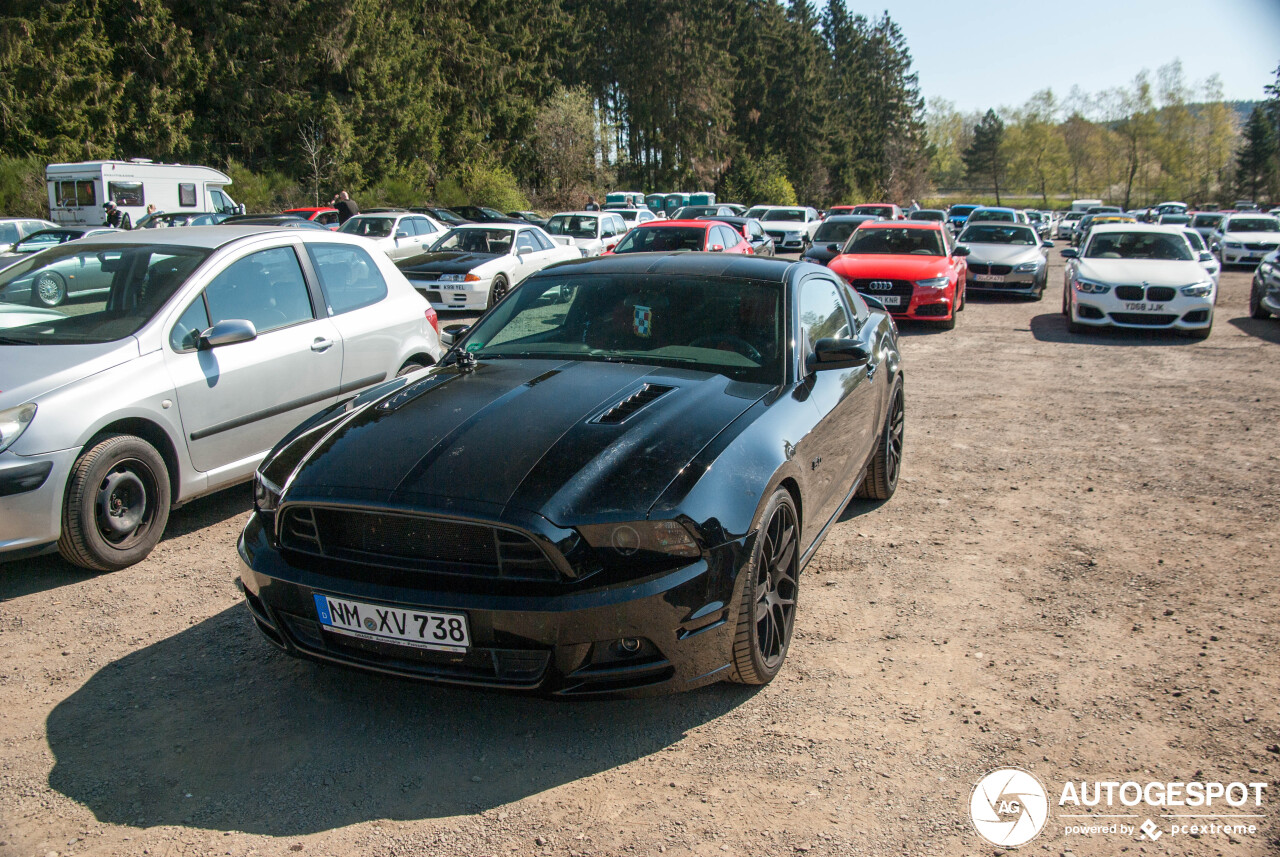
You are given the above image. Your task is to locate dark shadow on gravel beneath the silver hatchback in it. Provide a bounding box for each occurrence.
[0,484,253,601]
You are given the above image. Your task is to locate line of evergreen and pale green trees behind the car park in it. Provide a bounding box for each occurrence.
[0,0,1280,214]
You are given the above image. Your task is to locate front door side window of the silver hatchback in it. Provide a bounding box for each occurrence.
[205,247,314,334]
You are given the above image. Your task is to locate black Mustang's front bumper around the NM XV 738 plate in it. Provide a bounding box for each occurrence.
[238,514,750,696]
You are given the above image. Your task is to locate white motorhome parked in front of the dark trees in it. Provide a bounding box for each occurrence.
[45,157,242,226]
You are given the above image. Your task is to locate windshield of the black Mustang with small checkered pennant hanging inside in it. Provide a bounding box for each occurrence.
[455,271,785,384]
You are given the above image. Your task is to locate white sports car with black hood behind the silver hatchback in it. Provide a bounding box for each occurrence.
[396,223,584,310]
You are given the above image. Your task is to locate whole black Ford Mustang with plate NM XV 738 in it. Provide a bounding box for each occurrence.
[239,253,902,695]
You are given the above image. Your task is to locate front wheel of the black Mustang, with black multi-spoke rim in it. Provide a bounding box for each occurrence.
[730,489,800,684]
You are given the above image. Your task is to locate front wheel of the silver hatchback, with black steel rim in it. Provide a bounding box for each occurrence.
[58,435,170,572]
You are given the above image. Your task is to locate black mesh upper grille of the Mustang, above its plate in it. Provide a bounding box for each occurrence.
[280,507,561,581]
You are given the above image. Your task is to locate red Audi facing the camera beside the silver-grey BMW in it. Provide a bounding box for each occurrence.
[829,220,969,330]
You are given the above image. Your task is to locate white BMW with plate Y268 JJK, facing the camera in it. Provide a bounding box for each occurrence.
[1062,224,1217,339]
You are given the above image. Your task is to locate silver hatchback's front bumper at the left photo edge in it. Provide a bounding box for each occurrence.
[0,449,78,559]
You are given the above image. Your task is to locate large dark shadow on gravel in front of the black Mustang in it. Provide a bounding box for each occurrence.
[46,605,753,835]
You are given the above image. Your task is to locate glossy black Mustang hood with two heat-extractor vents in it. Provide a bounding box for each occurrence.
[276,359,769,526]
